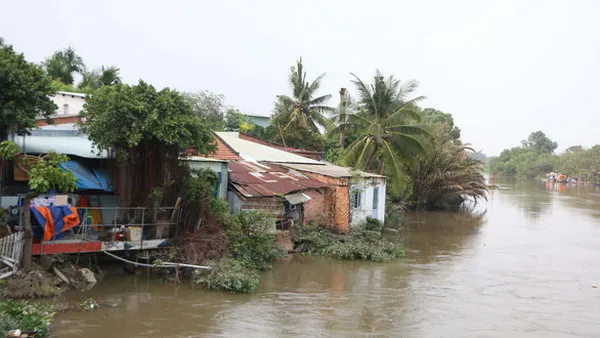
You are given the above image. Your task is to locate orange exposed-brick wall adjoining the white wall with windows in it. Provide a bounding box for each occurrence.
[298,170,350,232]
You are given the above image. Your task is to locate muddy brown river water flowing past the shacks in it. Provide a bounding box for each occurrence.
[52,182,600,338]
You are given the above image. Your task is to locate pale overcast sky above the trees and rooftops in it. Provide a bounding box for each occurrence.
[0,0,600,154]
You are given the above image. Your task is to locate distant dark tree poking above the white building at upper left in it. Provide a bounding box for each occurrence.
[43,47,85,85]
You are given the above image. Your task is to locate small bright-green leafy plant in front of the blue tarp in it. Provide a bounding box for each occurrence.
[28,152,76,193]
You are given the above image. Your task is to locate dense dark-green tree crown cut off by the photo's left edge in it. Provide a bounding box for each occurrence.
[0,38,57,134]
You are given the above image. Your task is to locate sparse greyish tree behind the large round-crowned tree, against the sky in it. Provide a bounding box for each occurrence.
[183,90,227,131]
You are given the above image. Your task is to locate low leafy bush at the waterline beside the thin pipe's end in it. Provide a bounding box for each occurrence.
[194,258,258,292]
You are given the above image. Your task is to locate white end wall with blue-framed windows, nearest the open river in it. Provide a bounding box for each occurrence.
[350,177,386,226]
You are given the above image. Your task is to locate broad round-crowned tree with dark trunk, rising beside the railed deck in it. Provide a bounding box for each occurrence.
[82,81,215,206]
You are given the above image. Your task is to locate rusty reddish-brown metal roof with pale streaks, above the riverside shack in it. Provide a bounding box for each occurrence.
[229,161,328,197]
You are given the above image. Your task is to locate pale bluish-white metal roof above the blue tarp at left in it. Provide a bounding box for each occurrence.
[14,123,108,159]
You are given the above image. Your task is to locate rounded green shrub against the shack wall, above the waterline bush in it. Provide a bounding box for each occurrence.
[225,211,283,270]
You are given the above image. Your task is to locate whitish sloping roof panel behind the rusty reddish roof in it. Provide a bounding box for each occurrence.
[216,132,322,165]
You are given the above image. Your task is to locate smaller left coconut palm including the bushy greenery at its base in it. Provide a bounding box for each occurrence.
[270,58,335,150]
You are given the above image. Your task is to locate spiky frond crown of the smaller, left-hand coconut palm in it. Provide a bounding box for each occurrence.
[276,58,334,133]
